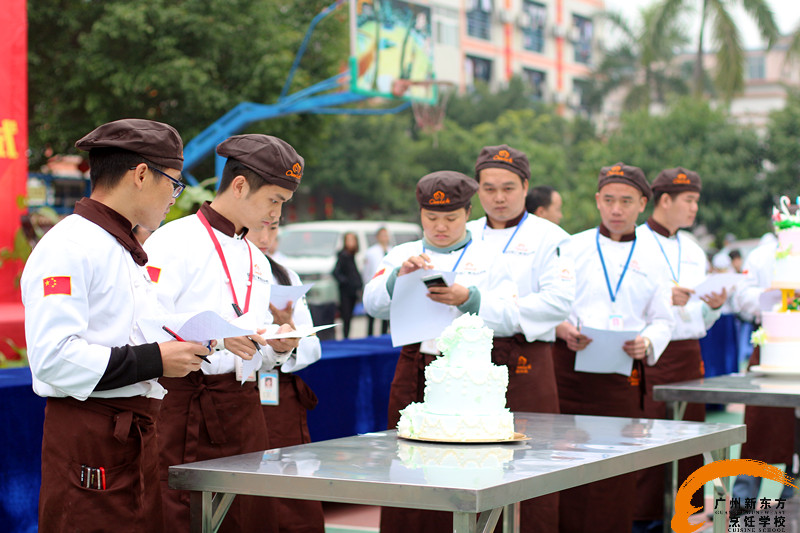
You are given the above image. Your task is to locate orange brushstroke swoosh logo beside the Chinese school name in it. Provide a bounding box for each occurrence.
[671,459,797,533]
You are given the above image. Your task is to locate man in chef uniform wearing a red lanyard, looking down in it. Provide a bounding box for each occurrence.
[145,134,304,531]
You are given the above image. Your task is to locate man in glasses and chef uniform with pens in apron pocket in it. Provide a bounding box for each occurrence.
[22,119,209,532]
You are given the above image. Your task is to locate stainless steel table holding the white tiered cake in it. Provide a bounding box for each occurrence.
[169,413,745,533]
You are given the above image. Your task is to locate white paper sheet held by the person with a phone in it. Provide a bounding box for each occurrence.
[389,269,456,346]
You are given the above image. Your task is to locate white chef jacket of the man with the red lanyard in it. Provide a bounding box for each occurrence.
[144,215,282,374]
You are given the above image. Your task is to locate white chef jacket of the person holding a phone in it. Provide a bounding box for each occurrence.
[363,235,519,337]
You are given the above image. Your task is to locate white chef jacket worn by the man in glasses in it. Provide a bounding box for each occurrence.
[21,215,166,400]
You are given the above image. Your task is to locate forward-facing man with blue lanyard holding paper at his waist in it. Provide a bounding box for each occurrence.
[554,163,674,532]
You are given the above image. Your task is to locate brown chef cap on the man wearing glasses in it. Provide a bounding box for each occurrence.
[75,118,183,170]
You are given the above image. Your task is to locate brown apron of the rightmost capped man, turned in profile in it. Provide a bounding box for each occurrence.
[634,339,706,520]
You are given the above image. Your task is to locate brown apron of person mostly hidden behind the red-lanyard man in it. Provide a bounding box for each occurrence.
[262,372,325,533]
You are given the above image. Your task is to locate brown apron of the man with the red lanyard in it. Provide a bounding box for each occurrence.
[158,372,278,532]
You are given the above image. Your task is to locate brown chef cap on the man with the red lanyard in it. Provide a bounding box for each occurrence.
[217,134,305,191]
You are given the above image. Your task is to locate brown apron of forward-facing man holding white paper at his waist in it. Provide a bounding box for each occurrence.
[553,339,643,533]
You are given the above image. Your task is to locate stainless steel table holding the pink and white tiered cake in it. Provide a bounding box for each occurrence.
[653,373,800,531]
